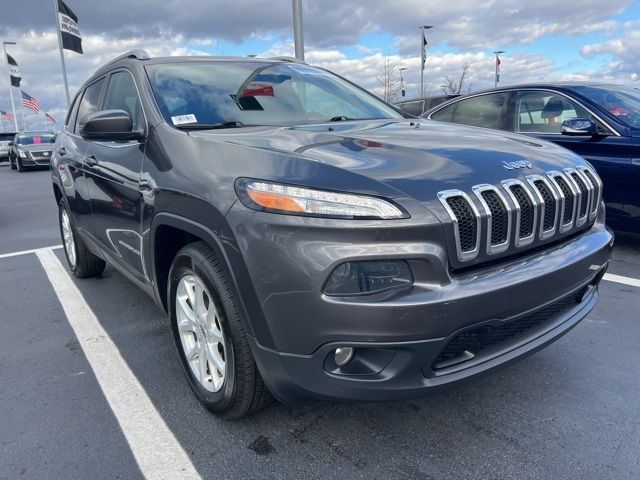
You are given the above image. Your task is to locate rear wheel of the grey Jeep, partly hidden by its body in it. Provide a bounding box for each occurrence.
[58,199,107,278]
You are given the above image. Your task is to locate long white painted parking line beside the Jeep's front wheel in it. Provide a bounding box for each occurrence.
[34,249,201,480]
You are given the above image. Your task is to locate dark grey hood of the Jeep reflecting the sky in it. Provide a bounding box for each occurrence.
[192,120,584,203]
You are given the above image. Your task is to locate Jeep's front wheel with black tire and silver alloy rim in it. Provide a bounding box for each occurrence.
[168,242,272,420]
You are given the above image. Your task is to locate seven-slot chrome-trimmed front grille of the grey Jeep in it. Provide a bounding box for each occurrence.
[438,166,602,262]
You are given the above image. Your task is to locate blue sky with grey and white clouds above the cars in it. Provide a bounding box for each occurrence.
[0,0,640,129]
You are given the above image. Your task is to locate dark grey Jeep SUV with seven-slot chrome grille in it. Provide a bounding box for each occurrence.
[51,51,613,418]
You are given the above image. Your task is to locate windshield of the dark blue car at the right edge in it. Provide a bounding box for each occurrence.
[573,85,640,128]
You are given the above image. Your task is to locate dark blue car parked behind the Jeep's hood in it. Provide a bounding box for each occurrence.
[425,83,640,233]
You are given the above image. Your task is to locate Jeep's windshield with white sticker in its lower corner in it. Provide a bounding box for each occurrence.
[147,62,402,126]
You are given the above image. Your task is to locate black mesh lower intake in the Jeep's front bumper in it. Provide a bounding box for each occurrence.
[432,289,584,370]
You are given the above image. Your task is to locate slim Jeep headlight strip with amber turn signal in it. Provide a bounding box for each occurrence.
[236,179,409,219]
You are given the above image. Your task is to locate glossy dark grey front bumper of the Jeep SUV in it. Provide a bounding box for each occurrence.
[228,204,613,401]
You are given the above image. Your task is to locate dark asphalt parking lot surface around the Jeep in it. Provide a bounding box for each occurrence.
[0,163,640,479]
